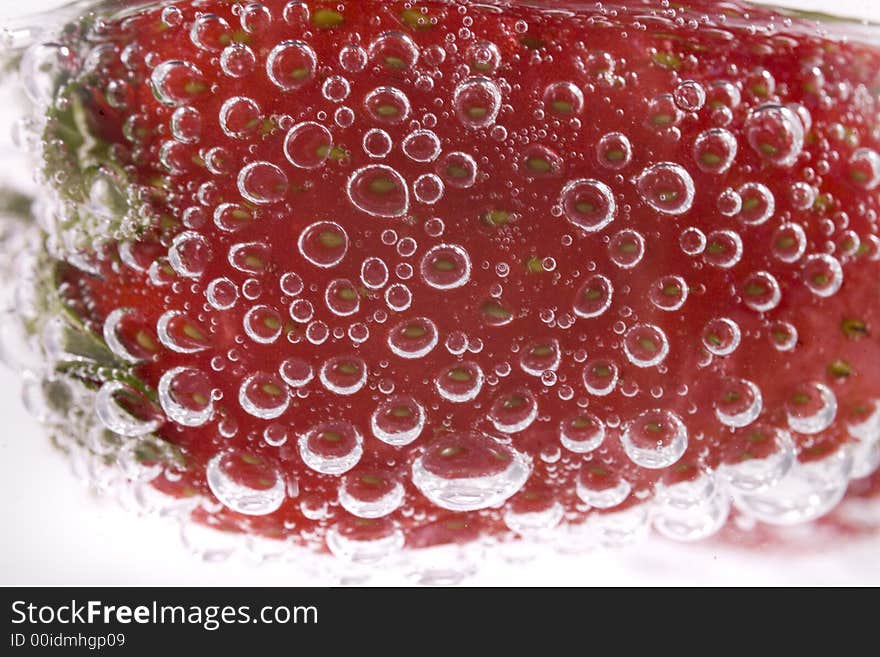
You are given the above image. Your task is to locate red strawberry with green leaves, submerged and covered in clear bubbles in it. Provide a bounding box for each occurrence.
[8,0,880,559]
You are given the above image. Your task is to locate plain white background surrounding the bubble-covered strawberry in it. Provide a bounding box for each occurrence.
[0,0,880,586]
